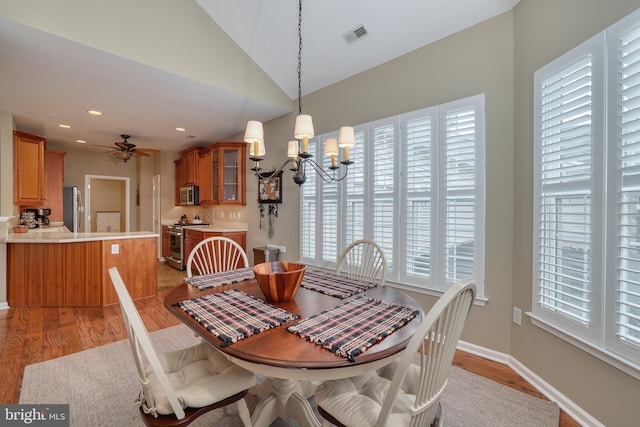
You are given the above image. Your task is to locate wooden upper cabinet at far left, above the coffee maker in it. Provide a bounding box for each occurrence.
[13,131,47,206]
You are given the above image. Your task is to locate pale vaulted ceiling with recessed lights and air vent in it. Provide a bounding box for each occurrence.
[0,0,518,151]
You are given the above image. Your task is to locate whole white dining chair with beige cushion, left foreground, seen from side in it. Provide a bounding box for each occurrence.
[109,267,256,427]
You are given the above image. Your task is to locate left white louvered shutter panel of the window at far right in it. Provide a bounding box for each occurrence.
[534,39,599,335]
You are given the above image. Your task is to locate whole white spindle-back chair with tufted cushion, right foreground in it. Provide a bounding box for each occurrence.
[315,282,476,427]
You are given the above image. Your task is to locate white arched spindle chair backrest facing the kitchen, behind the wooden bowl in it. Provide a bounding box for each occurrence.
[187,237,249,277]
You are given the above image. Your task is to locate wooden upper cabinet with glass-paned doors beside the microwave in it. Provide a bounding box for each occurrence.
[200,142,247,205]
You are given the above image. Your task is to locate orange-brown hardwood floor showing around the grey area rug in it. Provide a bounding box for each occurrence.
[0,263,579,427]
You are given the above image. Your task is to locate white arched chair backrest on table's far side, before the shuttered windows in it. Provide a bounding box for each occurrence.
[336,240,387,286]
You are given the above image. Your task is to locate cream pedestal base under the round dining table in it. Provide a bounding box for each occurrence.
[251,378,320,427]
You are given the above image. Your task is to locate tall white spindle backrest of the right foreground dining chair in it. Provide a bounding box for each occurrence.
[376,282,476,427]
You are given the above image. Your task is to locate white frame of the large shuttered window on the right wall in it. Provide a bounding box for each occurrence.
[527,10,640,379]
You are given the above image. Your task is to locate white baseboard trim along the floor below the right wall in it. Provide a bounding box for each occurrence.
[458,340,605,427]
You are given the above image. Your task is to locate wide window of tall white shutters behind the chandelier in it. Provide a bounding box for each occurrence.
[300,95,485,296]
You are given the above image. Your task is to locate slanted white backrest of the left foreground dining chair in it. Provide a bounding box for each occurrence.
[109,267,185,420]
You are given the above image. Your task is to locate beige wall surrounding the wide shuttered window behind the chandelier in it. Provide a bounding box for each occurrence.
[248,12,513,353]
